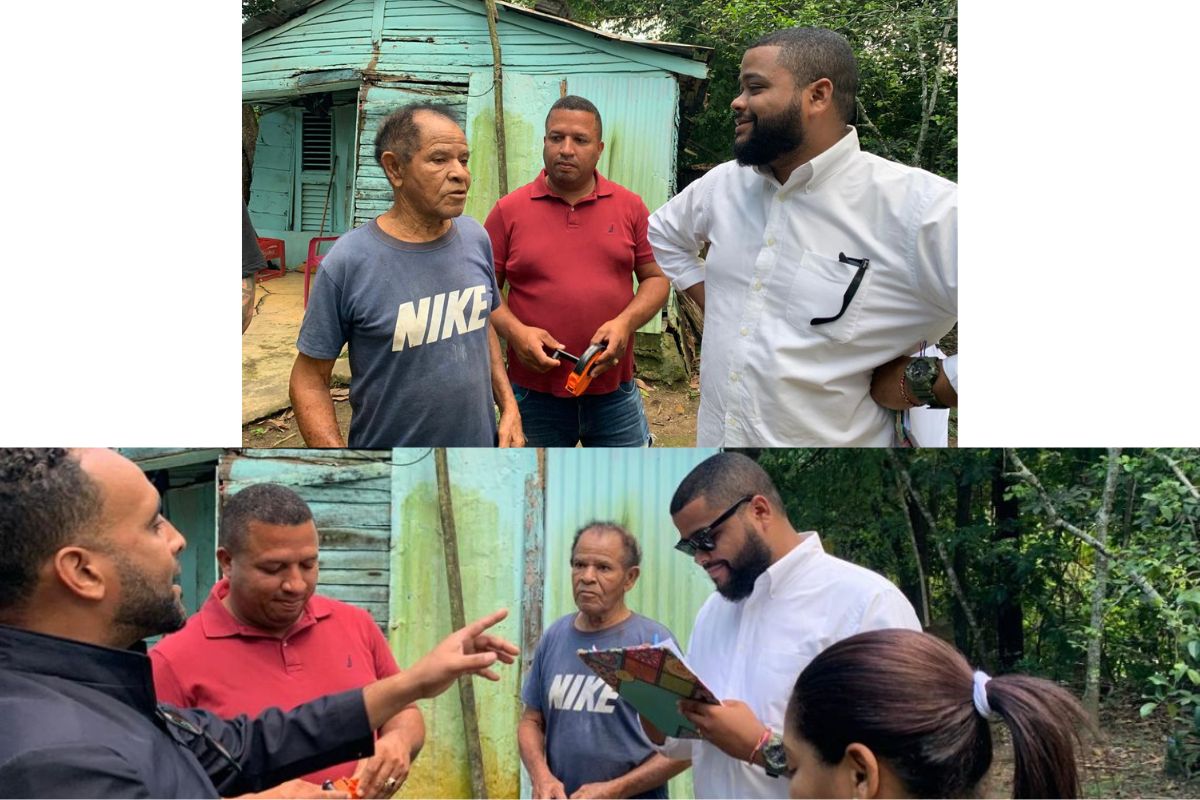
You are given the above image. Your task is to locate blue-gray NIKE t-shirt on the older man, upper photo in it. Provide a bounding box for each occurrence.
[296,217,500,449]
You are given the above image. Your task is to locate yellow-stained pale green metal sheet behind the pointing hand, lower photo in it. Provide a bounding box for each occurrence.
[390,450,538,798]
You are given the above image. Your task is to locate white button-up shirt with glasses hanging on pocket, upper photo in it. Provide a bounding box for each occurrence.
[649,127,958,447]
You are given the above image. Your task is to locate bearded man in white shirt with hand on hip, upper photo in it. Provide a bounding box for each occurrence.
[649,29,958,446]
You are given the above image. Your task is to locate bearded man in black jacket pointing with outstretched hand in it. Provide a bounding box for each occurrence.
[0,449,517,798]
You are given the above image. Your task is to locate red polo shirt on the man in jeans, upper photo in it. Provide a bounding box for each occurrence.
[484,169,654,397]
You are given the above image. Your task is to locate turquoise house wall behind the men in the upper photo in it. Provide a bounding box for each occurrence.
[242,0,706,281]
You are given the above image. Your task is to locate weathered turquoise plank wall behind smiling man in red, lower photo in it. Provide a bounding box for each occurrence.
[221,450,391,626]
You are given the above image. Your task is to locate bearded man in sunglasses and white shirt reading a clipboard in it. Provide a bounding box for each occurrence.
[642,452,920,798]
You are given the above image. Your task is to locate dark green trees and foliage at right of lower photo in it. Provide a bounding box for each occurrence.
[760,450,1200,775]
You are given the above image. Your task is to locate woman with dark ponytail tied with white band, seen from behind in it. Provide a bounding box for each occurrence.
[784,628,1086,798]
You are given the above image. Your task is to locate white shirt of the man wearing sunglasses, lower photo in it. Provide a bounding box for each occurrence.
[659,533,920,798]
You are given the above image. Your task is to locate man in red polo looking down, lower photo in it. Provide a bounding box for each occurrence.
[150,483,425,798]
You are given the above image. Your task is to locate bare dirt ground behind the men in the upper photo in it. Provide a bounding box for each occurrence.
[241,380,700,447]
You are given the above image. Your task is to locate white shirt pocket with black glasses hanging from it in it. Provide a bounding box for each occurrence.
[786,251,871,342]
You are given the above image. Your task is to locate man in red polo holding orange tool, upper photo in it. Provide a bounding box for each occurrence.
[484,95,670,447]
